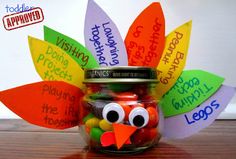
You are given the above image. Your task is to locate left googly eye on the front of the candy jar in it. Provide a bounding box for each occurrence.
[102,103,125,123]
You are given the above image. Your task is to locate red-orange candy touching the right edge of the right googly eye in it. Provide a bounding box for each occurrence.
[146,107,159,128]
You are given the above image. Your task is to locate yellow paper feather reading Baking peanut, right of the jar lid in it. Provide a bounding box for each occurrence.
[157,21,192,99]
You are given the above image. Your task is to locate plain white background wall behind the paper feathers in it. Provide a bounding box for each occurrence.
[0,0,236,118]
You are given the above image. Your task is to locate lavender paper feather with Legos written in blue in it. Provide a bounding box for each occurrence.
[163,85,235,138]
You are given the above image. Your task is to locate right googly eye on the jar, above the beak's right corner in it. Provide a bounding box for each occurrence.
[129,107,149,128]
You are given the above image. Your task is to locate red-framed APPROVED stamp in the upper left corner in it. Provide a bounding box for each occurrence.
[2,7,44,31]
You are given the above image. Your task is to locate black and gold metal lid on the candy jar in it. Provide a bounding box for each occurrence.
[84,66,158,83]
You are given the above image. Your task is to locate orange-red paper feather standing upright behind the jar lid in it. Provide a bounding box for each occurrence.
[125,2,165,67]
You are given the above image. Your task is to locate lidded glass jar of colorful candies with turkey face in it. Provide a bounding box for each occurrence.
[80,66,161,154]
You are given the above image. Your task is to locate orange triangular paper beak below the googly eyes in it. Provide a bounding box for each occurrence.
[113,123,137,150]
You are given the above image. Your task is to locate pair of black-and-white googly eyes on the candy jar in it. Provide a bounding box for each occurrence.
[102,103,149,128]
